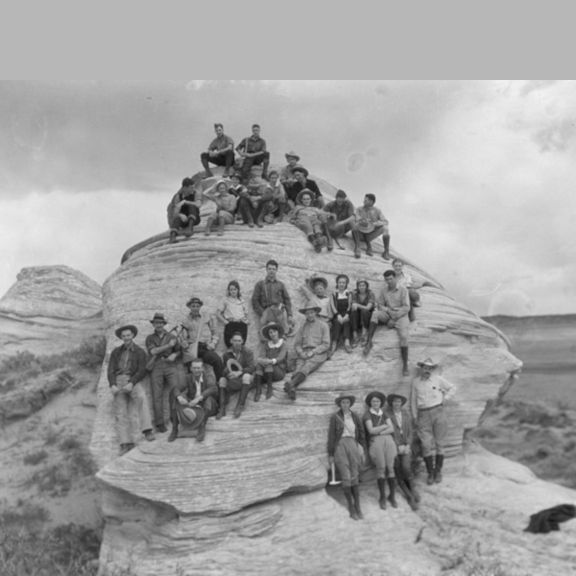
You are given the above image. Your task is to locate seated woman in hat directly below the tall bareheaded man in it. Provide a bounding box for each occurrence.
[254,322,288,402]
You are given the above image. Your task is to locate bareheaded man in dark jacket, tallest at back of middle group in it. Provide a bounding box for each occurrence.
[252,260,294,336]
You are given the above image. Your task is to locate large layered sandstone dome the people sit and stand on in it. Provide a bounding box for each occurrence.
[92,174,536,576]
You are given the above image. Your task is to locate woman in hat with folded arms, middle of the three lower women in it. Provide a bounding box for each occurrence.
[363,390,398,510]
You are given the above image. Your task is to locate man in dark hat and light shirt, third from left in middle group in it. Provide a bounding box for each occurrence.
[180,296,223,380]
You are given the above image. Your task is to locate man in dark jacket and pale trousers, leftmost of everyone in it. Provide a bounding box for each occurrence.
[108,324,154,456]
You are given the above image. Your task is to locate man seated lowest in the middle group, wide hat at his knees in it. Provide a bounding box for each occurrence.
[168,358,218,442]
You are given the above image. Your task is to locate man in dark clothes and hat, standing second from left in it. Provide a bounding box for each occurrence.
[146,312,184,432]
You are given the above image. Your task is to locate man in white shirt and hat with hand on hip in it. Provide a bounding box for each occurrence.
[410,358,456,484]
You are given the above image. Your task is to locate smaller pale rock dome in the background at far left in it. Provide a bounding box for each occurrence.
[0,266,103,356]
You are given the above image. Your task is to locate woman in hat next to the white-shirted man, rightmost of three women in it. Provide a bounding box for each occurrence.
[388,394,420,510]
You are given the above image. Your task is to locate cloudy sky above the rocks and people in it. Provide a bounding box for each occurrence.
[0,80,576,315]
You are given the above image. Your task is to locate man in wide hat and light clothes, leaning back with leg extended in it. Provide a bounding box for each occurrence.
[284,302,330,400]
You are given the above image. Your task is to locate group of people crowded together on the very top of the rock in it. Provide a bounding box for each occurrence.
[168,124,390,260]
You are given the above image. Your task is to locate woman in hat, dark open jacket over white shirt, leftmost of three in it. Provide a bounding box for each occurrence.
[328,394,366,520]
